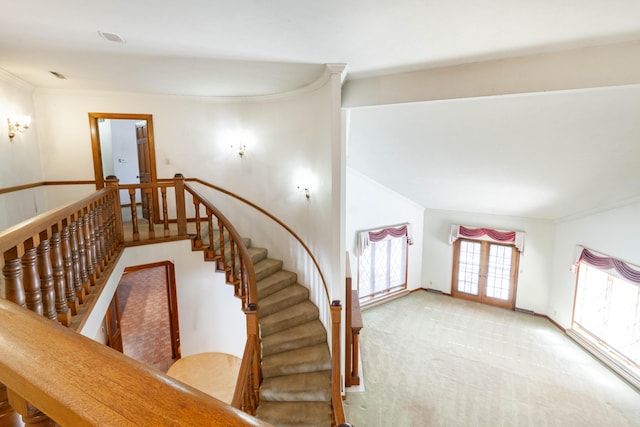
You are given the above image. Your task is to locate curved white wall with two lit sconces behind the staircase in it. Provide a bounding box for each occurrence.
[35,69,343,338]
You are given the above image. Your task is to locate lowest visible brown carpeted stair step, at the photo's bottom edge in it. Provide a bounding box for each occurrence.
[256,401,331,427]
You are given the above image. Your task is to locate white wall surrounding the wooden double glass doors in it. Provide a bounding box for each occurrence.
[422,209,554,314]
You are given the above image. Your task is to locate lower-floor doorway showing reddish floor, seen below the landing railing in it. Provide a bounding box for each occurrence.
[117,261,180,372]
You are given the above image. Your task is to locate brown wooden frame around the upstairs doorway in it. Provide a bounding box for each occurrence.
[89,113,160,222]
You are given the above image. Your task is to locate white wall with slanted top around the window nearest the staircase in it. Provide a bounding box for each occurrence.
[345,167,424,289]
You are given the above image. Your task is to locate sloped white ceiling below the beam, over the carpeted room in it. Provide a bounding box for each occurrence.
[348,85,640,219]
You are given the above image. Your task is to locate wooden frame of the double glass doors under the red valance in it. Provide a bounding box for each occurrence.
[451,238,520,310]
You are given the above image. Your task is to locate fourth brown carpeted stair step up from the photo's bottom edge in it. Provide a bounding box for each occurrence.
[262,319,327,356]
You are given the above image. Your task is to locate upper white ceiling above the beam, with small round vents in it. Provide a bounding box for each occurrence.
[0,0,640,96]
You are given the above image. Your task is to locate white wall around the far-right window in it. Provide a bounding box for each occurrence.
[548,201,640,328]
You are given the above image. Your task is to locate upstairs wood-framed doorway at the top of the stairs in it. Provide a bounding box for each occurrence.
[89,113,159,221]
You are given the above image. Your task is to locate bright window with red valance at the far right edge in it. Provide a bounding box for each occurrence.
[572,254,640,382]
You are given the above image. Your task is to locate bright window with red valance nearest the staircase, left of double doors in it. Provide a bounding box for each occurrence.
[358,226,410,303]
